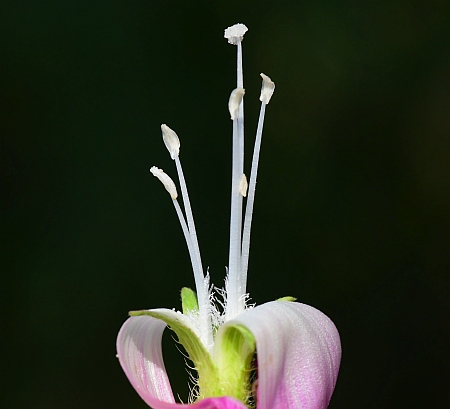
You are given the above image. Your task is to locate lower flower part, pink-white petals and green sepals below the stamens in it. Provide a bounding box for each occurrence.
[117,301,341,409]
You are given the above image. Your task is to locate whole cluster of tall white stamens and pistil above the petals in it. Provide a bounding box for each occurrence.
[150,24,275,342]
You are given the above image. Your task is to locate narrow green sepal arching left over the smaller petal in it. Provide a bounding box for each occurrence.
[129,310,223,399]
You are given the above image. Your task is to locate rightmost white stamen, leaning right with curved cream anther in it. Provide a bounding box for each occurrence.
[241,74,275,293]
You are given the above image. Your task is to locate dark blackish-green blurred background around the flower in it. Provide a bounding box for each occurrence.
[0,0,450,409]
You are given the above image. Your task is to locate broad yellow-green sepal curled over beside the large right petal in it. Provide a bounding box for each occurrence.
[214,324,256,403]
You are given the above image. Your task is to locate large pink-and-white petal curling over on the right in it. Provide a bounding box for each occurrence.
[221,301,341,409]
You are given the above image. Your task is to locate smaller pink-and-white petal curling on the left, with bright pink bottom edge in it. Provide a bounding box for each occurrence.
[117,310,247,409]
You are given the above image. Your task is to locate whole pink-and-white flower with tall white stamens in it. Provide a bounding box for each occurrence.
[117,24,341,409]
